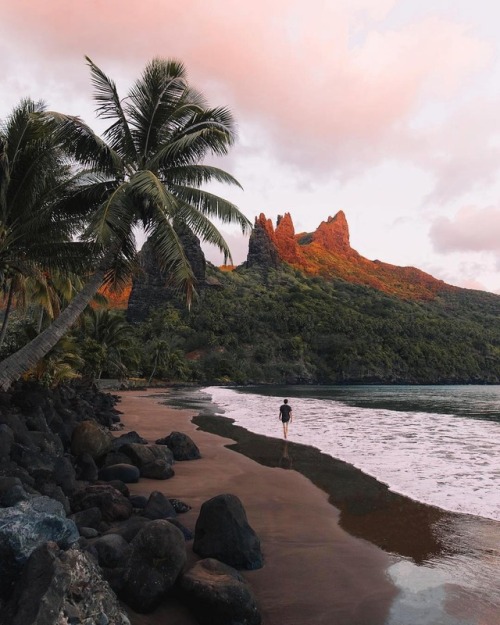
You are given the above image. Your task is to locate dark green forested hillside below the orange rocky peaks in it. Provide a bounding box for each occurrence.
[3,243,500,384]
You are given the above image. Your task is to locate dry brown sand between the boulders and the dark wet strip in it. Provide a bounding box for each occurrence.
[118,391,398,625]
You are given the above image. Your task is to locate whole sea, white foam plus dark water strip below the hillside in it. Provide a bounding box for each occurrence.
[203,386,500,521]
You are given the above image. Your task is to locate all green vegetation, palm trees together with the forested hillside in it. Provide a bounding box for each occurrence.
[0,59,500,389]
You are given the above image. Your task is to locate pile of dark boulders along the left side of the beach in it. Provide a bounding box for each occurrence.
[0,384,263,625]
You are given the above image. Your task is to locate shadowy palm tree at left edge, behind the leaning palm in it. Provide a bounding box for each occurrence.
[0,99,90,346]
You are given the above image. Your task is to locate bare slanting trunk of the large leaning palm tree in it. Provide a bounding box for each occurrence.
[0,269,106,391]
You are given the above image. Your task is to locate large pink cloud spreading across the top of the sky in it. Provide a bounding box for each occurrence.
[0,0,490,178]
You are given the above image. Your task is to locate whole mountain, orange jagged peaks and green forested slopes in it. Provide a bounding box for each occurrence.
[96,212,500,384]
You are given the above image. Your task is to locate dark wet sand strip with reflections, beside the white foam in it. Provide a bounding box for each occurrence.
[194,415,500,625]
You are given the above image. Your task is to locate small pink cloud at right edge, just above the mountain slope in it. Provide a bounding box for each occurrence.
[429,206,500,254]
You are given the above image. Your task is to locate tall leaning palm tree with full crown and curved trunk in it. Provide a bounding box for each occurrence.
[0,58,251,389]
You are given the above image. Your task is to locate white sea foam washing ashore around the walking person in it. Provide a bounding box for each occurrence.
[203,387,500,520]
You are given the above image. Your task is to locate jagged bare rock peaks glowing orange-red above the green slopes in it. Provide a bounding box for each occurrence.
[109,211,459,321]
